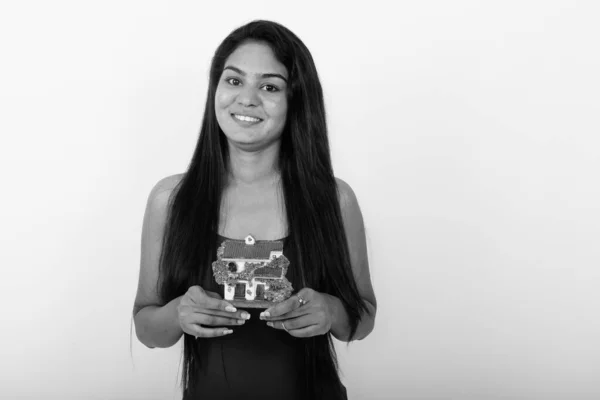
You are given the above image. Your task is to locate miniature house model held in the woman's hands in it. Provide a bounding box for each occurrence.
[213,236,292,307]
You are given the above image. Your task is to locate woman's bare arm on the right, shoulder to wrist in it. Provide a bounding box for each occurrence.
[326,179,377,341]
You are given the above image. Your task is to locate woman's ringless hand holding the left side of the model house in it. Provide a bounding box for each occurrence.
[177,286,250,339]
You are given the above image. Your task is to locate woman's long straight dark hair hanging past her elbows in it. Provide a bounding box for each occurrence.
[158,20,367,399]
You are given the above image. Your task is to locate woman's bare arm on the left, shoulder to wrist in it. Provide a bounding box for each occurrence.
[133,176,183,348]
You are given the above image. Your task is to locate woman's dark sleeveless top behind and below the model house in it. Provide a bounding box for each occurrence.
[183,235,305,400]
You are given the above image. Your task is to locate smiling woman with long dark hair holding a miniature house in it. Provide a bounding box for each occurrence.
[133,21,376,400]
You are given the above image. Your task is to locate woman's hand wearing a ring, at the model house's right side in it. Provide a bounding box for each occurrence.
[260,288,335,338]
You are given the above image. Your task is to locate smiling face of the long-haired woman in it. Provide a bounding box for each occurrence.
[215,42,288,150]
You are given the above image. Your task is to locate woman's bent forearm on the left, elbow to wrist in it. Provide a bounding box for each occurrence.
[133,297,183,348]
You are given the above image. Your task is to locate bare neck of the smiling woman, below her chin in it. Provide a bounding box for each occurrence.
[229,141,279,185]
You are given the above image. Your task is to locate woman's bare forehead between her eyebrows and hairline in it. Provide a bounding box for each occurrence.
[225,42,288,78]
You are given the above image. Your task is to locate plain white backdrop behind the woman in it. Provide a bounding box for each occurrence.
[0,0,600,400]
